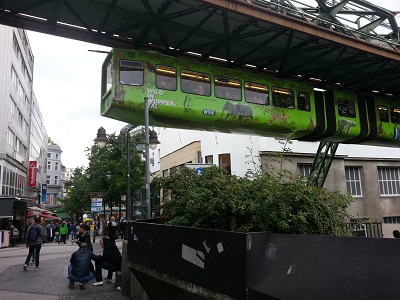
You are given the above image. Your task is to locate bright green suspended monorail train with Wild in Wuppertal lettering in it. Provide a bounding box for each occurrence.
[101,49,400,147]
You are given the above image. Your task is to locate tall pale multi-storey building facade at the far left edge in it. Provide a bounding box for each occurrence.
[0,26,34,197]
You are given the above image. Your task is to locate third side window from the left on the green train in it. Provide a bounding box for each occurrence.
[181,70,211,96]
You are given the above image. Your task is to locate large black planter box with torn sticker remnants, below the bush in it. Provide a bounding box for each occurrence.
[128,222,400,300]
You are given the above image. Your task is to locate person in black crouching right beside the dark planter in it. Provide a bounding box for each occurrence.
[92,237,122,286]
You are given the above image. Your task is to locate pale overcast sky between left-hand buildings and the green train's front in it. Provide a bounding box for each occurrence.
[28,32,125,168]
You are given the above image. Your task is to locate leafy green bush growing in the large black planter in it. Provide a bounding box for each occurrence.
[156,167,351,235]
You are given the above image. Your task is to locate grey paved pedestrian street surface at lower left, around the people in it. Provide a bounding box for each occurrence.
[0,240,129,300]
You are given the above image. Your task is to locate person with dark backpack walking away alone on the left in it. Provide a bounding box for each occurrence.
[23,218,46,271]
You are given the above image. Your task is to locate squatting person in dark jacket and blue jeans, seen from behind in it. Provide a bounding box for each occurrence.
[68,243,94,290]
